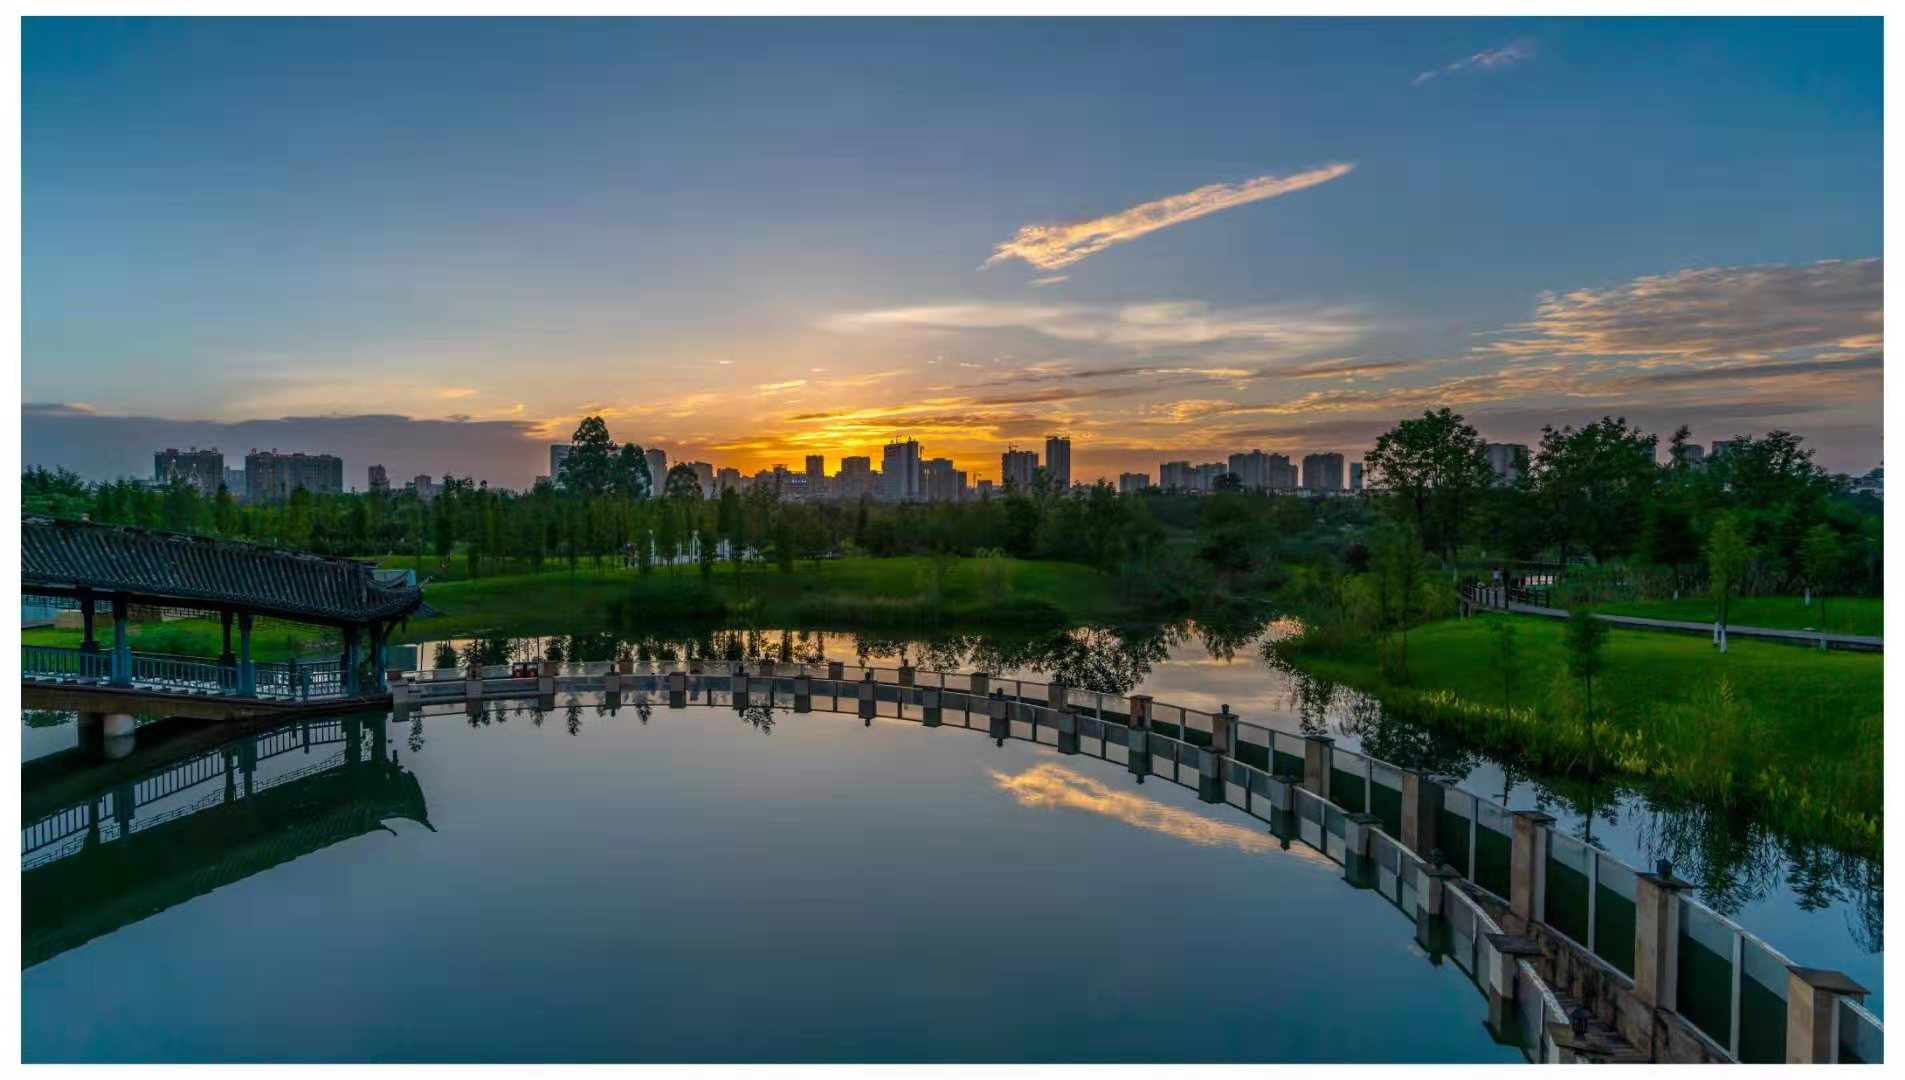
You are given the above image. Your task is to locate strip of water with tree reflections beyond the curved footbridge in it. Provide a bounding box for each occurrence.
[410,602,1884,952]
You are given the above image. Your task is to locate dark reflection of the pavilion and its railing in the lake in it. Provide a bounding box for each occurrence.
[21,716,429,968]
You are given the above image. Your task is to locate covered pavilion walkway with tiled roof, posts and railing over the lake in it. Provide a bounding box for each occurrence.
[21,516,423,727]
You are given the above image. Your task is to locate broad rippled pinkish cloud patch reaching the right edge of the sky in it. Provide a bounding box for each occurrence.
[1482,259,1884,364]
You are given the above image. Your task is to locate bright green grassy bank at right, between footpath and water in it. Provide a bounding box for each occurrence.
[1278,615,1884,857]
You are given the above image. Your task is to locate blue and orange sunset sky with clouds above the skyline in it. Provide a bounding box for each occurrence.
[21,19,1882,486]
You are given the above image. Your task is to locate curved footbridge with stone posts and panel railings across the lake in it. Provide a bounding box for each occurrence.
[389,661,1884,1063]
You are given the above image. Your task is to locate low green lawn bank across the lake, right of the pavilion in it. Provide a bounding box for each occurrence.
[390,558,1122,640]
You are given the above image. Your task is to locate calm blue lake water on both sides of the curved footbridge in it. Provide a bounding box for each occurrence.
[23,627,1884,1061]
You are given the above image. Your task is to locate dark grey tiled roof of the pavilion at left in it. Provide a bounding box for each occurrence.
[19,516,423,623]
